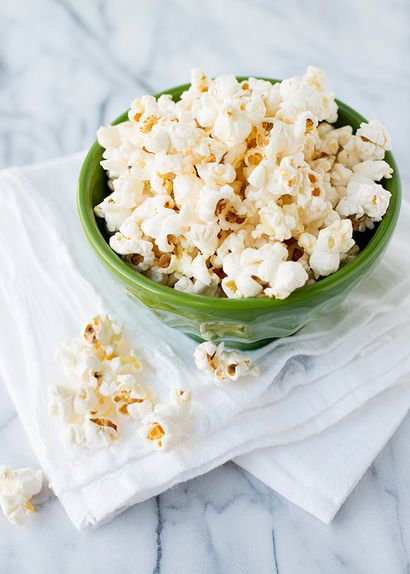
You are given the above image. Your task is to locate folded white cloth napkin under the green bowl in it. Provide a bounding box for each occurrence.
[0,154,410,530]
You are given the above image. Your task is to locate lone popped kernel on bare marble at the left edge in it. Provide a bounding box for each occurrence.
[0,466,43,526]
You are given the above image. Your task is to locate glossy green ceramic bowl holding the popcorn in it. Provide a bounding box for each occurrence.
[78,77,401,349]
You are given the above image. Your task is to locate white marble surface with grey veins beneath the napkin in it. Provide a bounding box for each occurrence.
[0,0,410,574]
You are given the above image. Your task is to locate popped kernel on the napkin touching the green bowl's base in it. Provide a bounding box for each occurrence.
[194,341,259,385]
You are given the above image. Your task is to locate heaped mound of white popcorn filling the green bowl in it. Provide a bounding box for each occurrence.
[95,67,392,299]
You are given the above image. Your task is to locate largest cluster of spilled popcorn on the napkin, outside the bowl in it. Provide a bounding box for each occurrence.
[48,314,190,450]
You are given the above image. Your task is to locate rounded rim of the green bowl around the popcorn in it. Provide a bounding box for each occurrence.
[77,76,401,311]
